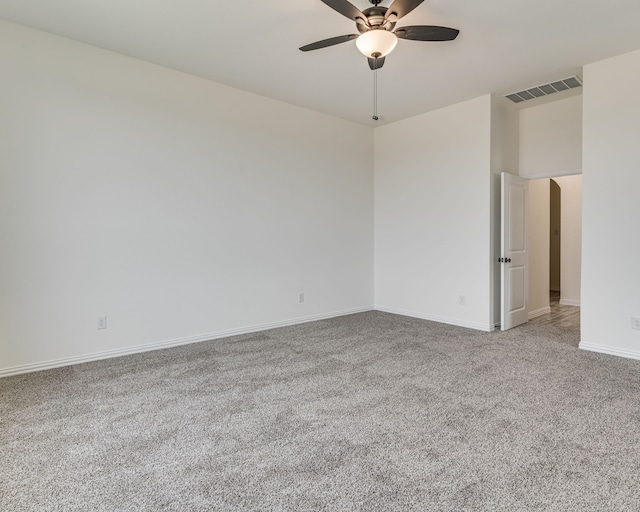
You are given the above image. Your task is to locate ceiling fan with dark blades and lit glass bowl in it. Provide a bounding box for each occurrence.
[300,0,460,70]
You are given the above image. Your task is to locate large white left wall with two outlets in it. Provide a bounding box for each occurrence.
[0,22,373,374]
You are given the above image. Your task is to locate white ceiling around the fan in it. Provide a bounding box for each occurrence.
[0,0,640,125]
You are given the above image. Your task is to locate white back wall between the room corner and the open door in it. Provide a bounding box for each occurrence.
[374,96,492,330]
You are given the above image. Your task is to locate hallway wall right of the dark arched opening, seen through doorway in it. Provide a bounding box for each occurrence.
[553,174,582,306]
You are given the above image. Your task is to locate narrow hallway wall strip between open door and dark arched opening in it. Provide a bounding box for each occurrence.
[529,179,550,318]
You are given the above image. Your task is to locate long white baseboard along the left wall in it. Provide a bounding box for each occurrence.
[0,306,373,378]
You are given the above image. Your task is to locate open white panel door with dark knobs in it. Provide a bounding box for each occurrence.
[498,172,529,331]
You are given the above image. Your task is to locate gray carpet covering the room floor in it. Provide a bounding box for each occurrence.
[0,312,640,511]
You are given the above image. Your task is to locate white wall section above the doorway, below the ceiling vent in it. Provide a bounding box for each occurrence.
[520,95,582,177]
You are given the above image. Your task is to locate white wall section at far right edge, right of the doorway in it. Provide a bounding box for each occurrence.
[580,51,640,358]
